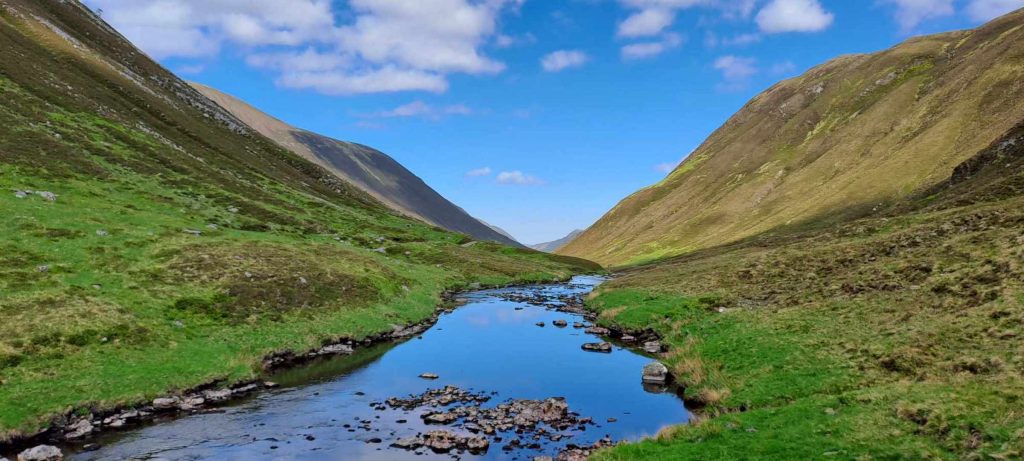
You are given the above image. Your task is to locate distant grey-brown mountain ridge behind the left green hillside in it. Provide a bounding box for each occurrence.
[191,83,520,246]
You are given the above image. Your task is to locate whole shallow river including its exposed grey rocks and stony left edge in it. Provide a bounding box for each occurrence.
[28,278,688,460]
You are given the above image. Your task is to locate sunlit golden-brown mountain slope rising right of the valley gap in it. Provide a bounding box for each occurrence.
[559,11,1024,265]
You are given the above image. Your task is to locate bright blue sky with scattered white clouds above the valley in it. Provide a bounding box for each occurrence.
[85,0,1024,244]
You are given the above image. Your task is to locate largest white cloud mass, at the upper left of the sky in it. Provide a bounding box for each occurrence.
[86,0,523,94]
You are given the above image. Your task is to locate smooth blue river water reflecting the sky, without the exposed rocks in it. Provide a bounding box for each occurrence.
[71,277,688,460]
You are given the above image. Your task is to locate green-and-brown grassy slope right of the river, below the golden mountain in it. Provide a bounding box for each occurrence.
[588,123,1024,460]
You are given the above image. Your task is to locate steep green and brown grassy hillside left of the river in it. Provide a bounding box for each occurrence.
[0,0,598,441]
